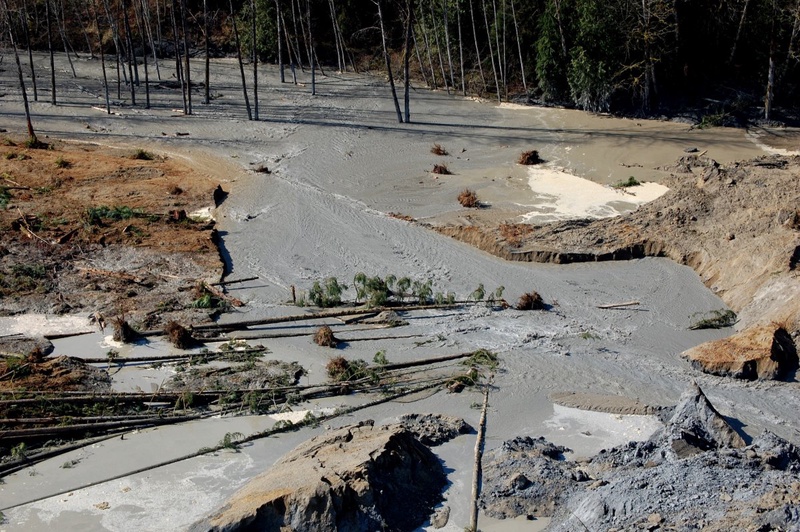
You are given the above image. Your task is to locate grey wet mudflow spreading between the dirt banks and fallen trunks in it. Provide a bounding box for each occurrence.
[0,52,800,531]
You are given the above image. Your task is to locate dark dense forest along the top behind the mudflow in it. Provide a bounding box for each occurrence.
[1,0,800,123]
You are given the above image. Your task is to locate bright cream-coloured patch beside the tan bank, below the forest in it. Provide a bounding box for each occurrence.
[522,168,669,223]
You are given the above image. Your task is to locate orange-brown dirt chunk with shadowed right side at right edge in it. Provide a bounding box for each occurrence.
[681,324,797,380]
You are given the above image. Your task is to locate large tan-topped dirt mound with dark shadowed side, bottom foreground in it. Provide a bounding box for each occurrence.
[190,425,447,532]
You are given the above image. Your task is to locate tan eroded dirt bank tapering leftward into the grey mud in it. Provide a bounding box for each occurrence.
[435,155,800,376]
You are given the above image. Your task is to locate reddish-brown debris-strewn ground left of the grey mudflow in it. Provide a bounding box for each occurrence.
[0,138,223,328]
